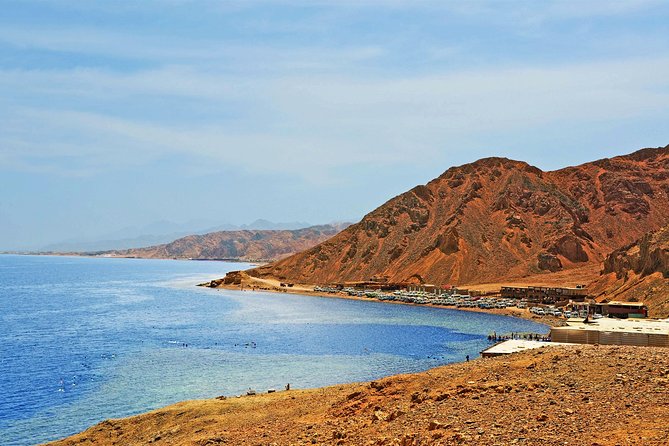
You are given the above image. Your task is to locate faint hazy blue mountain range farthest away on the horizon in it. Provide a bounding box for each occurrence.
[40,219,312,252]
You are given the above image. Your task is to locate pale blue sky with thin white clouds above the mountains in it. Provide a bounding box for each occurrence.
[0,0,669,250]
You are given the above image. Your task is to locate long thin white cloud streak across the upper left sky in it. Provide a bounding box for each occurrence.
[0,25,385,75]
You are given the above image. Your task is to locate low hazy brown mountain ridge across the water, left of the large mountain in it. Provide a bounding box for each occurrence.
[104,223,347,261]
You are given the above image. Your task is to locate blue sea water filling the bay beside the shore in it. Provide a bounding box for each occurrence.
[0,255,547,445]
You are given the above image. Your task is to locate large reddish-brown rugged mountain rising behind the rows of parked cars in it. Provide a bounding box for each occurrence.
[249,146,669,285]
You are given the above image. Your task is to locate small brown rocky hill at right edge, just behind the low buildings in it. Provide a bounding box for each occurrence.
[588,225,669,317]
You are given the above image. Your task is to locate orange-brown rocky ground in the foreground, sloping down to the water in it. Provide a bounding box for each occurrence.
[49,345,669,446]
